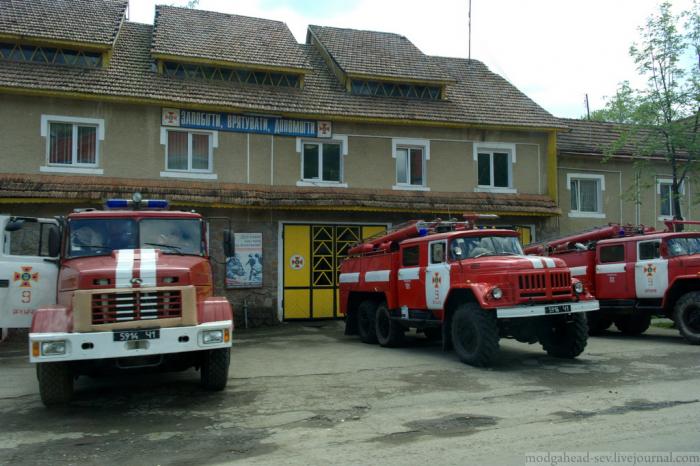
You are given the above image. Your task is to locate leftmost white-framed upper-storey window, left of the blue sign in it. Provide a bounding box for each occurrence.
[39,115,105,175]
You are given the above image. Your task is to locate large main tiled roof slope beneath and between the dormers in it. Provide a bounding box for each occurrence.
[0,22,565,128]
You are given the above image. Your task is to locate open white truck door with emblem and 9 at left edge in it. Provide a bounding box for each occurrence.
[0,216,58,328]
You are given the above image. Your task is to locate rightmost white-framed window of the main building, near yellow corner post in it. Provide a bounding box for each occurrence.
[474,142,517,193]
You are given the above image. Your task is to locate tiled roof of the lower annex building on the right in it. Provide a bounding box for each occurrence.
[557,118,663,156]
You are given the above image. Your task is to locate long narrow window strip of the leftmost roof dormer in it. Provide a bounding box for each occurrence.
[0,42,102,68]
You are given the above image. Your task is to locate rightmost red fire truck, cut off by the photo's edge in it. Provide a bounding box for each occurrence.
[525,220,700,344]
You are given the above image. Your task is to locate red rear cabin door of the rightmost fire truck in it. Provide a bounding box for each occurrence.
[595,243,634,299]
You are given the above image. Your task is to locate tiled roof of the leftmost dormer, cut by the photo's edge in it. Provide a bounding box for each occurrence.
[0,0,127,45]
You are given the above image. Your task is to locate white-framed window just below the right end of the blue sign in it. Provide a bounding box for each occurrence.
[297,135,348,188]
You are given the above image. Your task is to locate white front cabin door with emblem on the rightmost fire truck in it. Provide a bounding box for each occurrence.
[634,239,668,299]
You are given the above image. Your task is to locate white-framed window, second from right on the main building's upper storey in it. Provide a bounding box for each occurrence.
[391,138,430,191]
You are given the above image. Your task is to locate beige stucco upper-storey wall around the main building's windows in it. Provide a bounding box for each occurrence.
[0,95,547,194]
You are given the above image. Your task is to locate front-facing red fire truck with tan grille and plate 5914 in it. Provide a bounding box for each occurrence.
[11,195,233,406]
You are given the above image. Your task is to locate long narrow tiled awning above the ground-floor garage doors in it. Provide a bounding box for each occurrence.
[0,174,561,216]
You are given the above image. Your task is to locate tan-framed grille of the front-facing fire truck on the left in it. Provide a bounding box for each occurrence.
[92,290,182,325]
